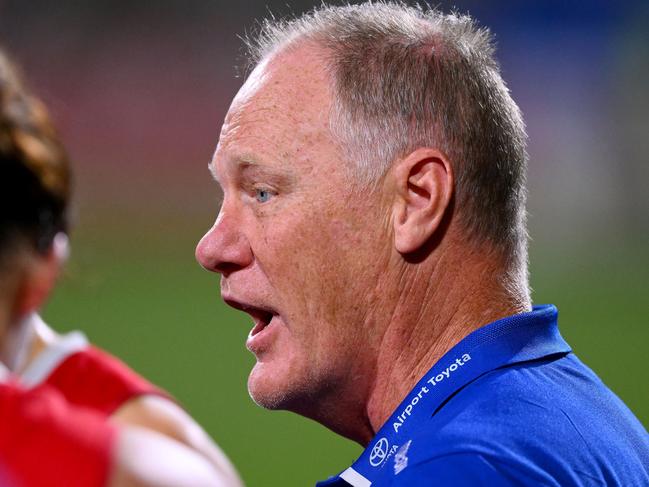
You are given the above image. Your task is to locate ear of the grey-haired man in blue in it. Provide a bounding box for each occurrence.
[393,148,453,254]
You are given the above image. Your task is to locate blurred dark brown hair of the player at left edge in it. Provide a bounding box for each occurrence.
[0,50,70,254]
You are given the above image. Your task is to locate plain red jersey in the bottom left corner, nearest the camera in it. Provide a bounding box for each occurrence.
[0,383,116,487]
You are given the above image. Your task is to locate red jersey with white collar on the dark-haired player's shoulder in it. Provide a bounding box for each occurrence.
[21,332,170,416]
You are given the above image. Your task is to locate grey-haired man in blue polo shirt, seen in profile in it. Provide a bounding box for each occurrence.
[196,2,649,487]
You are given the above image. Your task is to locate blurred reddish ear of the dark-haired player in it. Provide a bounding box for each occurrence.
[12,233,68,320]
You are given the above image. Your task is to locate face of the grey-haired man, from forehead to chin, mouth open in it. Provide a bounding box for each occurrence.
[196,45,389,414]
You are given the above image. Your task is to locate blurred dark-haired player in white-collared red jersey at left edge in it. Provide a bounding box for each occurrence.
[0,46,241,486]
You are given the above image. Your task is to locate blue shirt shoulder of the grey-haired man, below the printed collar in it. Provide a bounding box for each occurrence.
[384,356,649,485]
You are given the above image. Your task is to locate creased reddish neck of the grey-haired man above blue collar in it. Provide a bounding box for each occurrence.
[362,244,531,445]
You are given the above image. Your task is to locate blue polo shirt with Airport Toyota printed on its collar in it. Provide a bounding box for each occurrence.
[318,305,649,487]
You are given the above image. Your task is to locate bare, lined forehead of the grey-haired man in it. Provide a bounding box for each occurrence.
[220,43,331,158]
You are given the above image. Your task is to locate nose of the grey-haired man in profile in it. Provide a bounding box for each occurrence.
[196,213,252,277]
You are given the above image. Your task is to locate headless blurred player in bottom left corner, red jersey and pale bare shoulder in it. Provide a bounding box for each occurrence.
[0,366,223,487]
